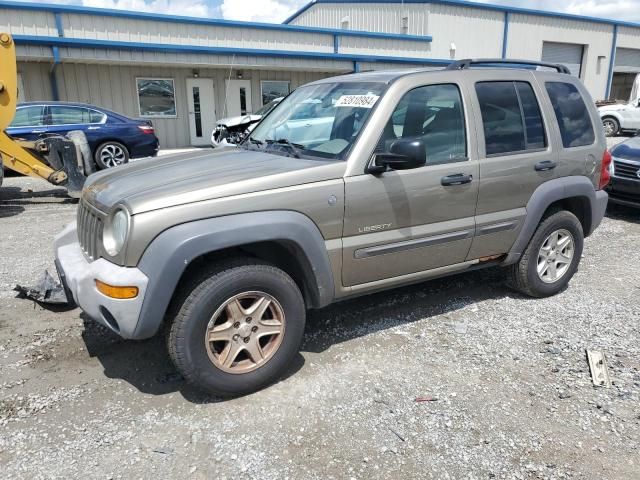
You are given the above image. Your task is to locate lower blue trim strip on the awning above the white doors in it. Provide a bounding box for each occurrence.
[13,35,451,65]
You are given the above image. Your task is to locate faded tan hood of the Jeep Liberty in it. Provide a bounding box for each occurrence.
[82,147,346,214]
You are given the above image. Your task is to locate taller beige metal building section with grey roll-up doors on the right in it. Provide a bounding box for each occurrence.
[285,0,640,99]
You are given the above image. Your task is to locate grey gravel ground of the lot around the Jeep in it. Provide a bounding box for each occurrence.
[0,147,640,479]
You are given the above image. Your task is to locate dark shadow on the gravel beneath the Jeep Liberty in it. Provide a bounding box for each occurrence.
[82,269,512,403]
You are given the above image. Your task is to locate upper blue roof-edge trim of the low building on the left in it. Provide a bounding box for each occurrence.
[0,0,433,42]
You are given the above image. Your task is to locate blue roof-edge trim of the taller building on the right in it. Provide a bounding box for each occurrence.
[284,0,640,28]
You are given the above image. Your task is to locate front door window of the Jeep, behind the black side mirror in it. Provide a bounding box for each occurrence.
[376,84,467,165]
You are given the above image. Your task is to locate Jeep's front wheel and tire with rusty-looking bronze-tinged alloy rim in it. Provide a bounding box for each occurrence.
[167,259,306,397]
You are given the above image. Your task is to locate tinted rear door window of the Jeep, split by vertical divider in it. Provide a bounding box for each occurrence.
[476,82,547,155]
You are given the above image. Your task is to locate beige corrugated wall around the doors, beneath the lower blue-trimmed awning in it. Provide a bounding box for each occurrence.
[18,62,333,148]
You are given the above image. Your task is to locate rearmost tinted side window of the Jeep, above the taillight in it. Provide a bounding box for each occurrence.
[546,82,595,148]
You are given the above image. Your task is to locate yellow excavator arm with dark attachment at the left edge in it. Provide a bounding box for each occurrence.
[0,33,93,197]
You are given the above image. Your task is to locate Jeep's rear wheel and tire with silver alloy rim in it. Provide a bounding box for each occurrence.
[507,210,584,298]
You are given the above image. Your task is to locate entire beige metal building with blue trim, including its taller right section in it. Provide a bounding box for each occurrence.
[0,0,640,148]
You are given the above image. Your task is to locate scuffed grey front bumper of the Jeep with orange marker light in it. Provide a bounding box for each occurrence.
[54,222,149,338]
